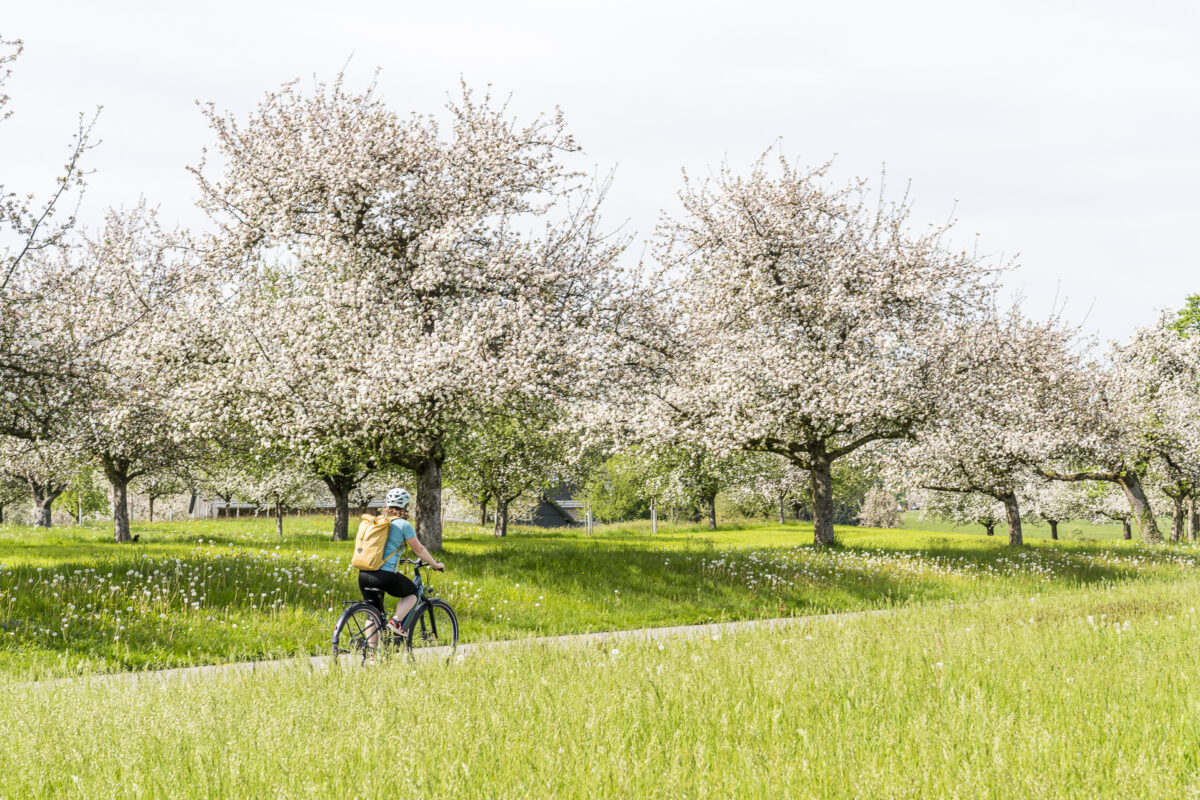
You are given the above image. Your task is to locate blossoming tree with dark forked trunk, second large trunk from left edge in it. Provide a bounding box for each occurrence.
[55,204,199,542]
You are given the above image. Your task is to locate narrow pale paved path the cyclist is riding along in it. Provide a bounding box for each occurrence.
[25,609,888,687]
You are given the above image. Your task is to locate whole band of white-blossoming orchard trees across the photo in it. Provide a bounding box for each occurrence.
[0,37,1200,548]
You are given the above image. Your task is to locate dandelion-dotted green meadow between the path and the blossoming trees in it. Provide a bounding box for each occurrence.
[0,517,1200,680]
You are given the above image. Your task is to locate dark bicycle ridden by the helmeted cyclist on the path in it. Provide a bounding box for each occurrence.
[334,559,458,666]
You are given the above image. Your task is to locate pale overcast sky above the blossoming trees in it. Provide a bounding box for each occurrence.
[0,0,1200,339]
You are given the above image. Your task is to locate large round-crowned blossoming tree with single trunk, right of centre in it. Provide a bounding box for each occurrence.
[641,157,988,546]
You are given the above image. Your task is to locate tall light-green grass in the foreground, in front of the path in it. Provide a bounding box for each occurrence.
[0,576,1200,799]
